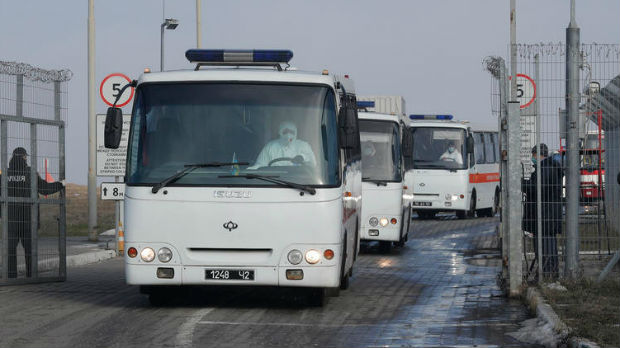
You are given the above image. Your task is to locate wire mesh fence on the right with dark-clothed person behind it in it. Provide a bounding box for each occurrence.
[485,43,620,281]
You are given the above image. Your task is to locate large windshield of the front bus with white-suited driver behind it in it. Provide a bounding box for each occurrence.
[127,82,340,187]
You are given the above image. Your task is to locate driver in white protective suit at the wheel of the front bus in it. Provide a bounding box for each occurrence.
[248,121,316,169]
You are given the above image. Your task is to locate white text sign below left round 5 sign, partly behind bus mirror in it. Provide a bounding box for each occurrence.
[97,115,131,176]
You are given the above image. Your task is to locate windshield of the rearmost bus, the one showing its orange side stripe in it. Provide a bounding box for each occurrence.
[411,127,467,170]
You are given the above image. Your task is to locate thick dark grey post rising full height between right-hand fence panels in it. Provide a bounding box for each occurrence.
[564,0,581,279]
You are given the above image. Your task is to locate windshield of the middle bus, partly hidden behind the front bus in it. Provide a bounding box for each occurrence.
[359,120,402,182]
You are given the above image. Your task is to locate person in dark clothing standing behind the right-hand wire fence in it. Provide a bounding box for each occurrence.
[522,144,563,279]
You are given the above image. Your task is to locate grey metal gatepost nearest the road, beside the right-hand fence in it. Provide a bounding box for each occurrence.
[507,101,523,296]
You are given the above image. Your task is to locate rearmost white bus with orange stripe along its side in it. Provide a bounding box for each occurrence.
[405,115,500,219]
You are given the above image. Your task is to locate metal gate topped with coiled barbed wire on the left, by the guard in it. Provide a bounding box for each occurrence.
[0,61,72,285]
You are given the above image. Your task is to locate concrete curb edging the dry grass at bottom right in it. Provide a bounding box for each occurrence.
[526,288,599,348]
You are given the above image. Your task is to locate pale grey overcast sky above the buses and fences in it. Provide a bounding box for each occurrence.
[0,0,620,184]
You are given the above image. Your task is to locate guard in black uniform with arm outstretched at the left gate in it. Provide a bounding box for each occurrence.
[7,147,64,278]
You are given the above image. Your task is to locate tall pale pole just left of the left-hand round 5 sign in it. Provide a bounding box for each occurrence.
[88,0,97,241]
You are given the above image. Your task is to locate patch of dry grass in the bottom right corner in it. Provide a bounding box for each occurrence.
[542,278,620,347]
